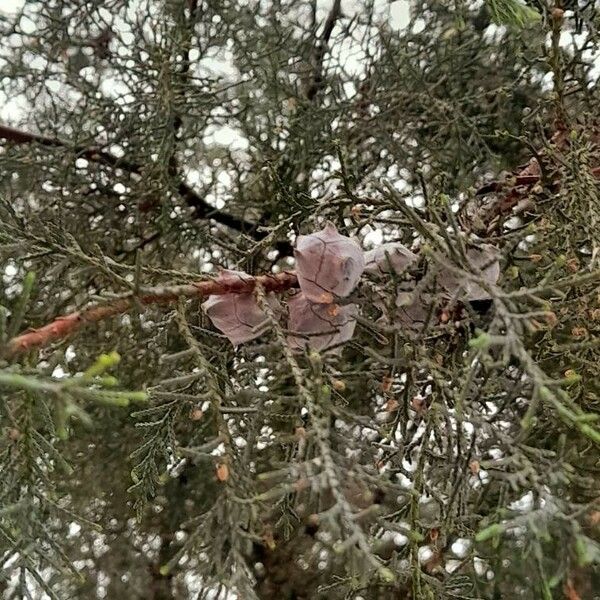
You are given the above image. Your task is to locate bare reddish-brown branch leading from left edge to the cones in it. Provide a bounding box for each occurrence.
[1,272,298,358]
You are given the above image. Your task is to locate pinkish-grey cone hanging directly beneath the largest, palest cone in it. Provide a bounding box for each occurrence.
[288,292,358,351]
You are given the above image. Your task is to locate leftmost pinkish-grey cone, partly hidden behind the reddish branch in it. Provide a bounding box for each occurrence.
[202,270,281,346]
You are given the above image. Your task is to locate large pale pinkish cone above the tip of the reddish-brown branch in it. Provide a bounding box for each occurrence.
[294,223,365,304]
